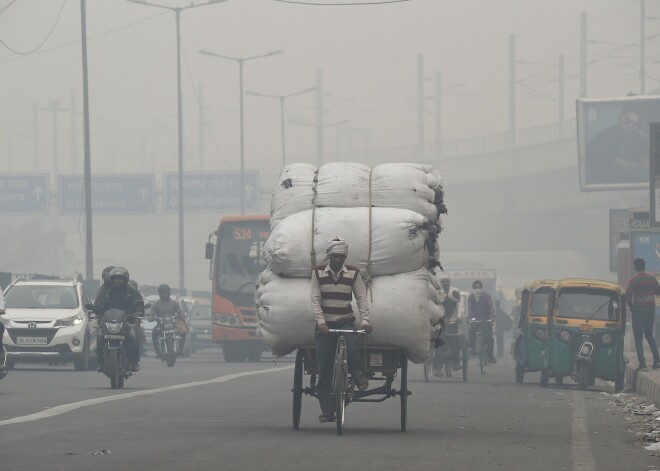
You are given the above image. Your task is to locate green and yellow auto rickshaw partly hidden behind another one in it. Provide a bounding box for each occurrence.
[513,280,563,383]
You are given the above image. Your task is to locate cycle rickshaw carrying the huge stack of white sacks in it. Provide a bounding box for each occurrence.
[291,329,411,435]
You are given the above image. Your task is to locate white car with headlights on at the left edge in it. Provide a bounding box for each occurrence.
[0,280,98,371]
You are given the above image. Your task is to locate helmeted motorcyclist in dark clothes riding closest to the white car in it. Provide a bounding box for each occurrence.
[94,267,144,372]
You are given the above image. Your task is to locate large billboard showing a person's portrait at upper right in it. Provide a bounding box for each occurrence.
[577,96,660,191]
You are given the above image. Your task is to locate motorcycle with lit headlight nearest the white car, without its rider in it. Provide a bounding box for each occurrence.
[93,309,139,389]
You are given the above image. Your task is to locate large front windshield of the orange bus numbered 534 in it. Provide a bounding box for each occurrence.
[216,220,270,294]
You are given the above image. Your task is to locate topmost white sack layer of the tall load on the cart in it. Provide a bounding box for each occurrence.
[270,162,446,227]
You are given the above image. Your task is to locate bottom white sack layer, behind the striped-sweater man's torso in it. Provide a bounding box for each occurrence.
[255,268,444,363]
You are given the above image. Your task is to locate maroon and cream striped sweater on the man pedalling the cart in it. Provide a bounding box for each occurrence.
[311,264,369,325]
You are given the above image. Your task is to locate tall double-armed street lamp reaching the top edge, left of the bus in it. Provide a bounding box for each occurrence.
[128,0,226,290]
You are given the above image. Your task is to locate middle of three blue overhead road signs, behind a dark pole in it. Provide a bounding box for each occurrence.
[59,175,155,214]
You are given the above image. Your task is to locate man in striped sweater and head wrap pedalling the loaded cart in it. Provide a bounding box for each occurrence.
[311,237,372,423]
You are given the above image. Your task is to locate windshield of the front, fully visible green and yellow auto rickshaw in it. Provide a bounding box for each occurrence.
[557,288,619,320]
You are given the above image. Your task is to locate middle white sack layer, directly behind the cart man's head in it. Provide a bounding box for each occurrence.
[262,208,437,278]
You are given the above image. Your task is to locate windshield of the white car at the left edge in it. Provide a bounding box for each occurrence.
[5,285,78,309]
